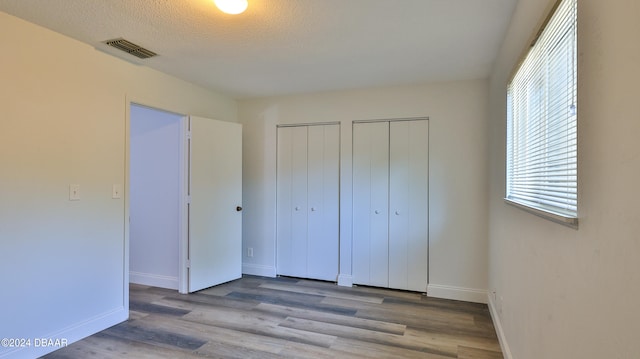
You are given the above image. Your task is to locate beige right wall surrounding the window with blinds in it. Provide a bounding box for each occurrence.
[489,0,640,359]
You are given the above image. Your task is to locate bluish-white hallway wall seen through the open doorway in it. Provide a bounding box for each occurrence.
[129,105,184,290]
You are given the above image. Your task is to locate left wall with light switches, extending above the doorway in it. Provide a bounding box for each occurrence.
[0,13,236,358]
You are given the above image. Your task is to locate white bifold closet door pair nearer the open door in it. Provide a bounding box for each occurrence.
[276,124,340,281]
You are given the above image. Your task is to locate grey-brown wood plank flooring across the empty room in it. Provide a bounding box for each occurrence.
[45,276,503,359]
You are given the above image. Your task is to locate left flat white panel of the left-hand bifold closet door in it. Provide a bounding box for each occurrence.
[276,127,307,276]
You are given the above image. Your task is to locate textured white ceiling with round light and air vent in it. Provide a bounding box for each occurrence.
[0,0,517,98]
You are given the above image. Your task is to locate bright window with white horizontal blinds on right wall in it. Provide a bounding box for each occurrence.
[506,0,578,225]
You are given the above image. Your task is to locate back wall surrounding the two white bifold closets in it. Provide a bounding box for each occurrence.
[238,80,488,301]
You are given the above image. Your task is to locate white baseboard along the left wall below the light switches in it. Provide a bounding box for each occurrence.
[0,307,129,359]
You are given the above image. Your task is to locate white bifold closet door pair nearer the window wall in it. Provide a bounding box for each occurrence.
[353,120,429,292]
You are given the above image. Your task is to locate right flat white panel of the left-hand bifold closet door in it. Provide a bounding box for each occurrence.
[307,124,340,281]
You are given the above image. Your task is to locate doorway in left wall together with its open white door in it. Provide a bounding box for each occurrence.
[125,102,242,293]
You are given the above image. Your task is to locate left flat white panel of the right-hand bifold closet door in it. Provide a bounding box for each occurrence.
[353,122,389,287]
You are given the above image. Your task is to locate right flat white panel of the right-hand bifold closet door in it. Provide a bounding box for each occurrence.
[389,120,429,292]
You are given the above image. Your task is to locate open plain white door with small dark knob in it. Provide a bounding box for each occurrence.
[188,116,242,292]
